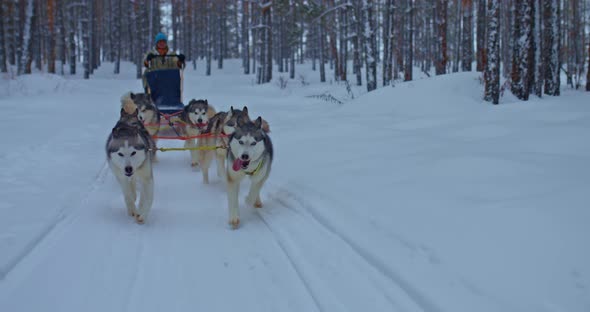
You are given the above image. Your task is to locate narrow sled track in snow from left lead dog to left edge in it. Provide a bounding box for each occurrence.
[0,161,109,281]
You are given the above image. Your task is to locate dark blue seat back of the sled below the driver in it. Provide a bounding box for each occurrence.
[145,69,184,114]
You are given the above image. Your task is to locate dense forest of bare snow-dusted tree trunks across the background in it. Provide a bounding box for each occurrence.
[0,0,590,104]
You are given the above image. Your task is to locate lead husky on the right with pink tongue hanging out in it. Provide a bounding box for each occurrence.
[226,117,273,229]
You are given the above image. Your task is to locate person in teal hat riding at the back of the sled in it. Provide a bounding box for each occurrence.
[142,33,185,93]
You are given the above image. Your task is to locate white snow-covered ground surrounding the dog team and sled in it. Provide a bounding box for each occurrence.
[0,61,590,312]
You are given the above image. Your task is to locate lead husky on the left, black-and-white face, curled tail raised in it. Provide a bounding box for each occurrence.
[106,103,155,224]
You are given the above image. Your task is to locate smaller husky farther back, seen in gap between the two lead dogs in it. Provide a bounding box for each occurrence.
[180,99,220,179]
